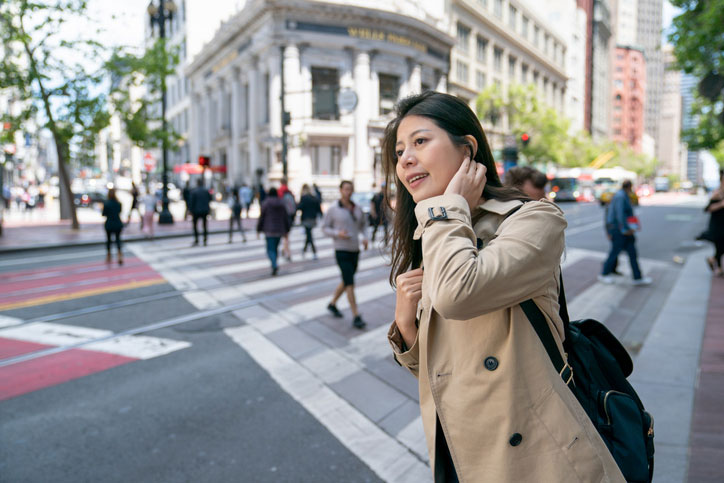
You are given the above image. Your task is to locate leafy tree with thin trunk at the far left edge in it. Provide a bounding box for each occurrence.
[0,0,109,229]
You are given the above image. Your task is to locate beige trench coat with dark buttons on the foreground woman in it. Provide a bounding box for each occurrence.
[389,195,624,483]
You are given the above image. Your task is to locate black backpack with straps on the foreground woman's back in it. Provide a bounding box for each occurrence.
[520,276,654,482]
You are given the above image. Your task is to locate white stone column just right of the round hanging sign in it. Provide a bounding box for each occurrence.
[353,51,374,191]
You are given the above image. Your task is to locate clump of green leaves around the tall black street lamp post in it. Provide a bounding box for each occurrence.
[106,39,181,149]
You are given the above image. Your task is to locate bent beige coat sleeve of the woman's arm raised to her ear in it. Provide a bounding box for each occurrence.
[415,195,566,320]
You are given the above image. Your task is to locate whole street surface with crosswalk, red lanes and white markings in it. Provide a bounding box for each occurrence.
[0,199,709,482]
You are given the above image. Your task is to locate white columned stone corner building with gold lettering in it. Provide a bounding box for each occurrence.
[185,0,454,194]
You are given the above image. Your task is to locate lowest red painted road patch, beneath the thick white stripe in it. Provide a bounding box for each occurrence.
[0,349,137,401]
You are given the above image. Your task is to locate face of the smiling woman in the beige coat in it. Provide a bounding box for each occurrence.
[395,116,470,203]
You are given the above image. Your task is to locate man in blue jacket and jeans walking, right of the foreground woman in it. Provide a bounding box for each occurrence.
[598,180,651,285]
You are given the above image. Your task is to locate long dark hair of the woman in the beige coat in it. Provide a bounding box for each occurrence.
[382,91,530,286]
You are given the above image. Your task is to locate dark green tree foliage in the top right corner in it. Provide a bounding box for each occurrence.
[669,0,724,149]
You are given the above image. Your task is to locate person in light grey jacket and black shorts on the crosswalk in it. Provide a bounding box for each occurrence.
[322,180,369,329]
